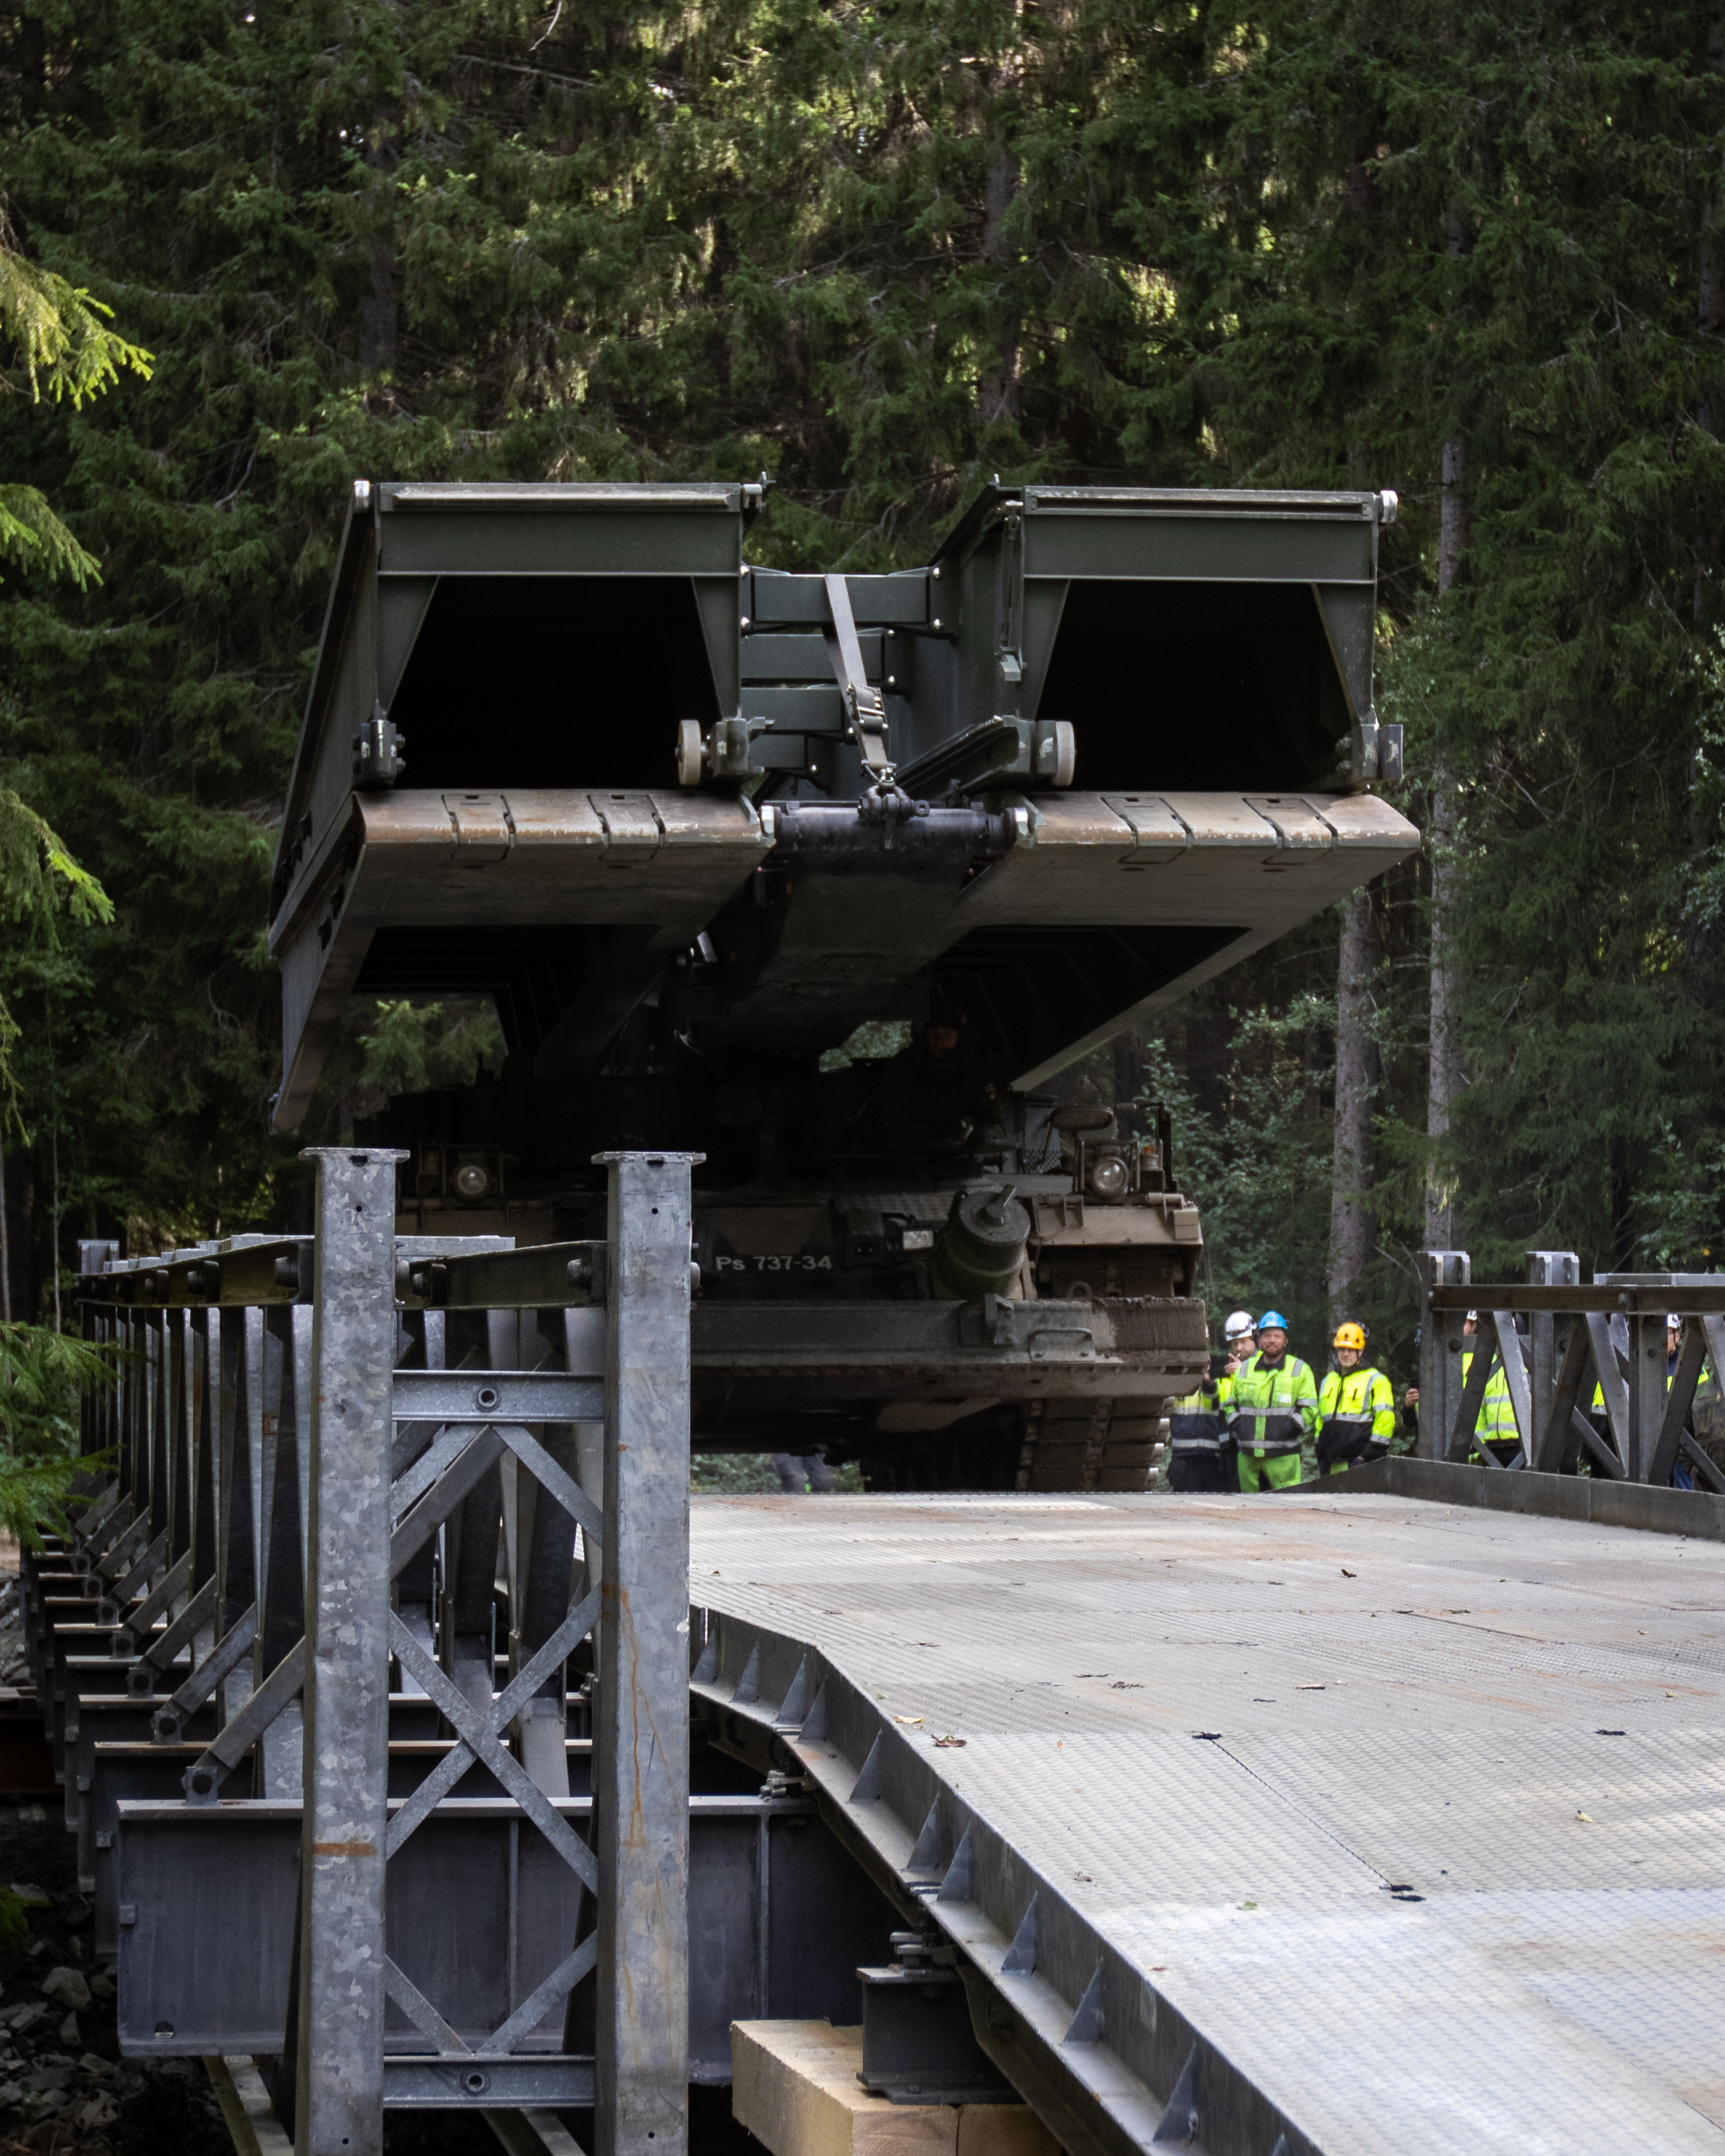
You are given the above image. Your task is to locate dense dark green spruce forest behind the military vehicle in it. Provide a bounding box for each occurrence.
[0,0,1725,1356]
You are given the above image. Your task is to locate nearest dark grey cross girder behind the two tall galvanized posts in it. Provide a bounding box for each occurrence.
[119,1794,895,2078]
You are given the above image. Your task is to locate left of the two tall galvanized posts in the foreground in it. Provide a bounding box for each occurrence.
[293,1147,406,2156]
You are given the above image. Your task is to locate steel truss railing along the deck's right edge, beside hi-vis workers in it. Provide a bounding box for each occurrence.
[1419,1250,1725,1492]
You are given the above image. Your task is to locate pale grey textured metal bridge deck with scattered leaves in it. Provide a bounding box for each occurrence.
[692,1494,1725,2156]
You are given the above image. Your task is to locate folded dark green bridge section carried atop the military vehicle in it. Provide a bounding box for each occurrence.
[272,483,1416,1129]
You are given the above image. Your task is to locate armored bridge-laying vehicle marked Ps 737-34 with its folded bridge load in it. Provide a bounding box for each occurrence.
[272,481,1419,1490]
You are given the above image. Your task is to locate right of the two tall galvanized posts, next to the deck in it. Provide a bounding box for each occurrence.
[593,1153,701,2156]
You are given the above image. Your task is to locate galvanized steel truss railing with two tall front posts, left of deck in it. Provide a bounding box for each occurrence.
[54,1147,698,2156]
